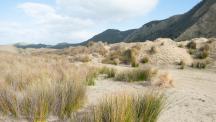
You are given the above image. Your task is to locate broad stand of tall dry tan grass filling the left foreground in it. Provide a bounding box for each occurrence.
[0,53,90,121]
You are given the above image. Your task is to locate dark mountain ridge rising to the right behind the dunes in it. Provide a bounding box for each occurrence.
[87,0,216,43]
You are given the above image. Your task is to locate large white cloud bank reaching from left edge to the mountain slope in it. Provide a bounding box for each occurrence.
[0,0,158,44]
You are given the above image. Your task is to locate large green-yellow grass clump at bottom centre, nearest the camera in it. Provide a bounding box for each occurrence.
[80,93,166,122]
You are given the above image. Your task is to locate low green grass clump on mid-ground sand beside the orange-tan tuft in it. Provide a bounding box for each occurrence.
[115,68,157,82]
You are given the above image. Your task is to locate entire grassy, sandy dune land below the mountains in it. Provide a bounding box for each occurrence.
[0,38,216,122]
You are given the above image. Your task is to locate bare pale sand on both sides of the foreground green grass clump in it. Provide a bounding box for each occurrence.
[81,68,216,122]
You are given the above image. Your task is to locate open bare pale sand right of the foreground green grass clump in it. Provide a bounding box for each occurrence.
[159,69,216,122]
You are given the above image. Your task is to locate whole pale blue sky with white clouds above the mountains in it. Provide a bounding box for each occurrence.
[0,0,200,44]
